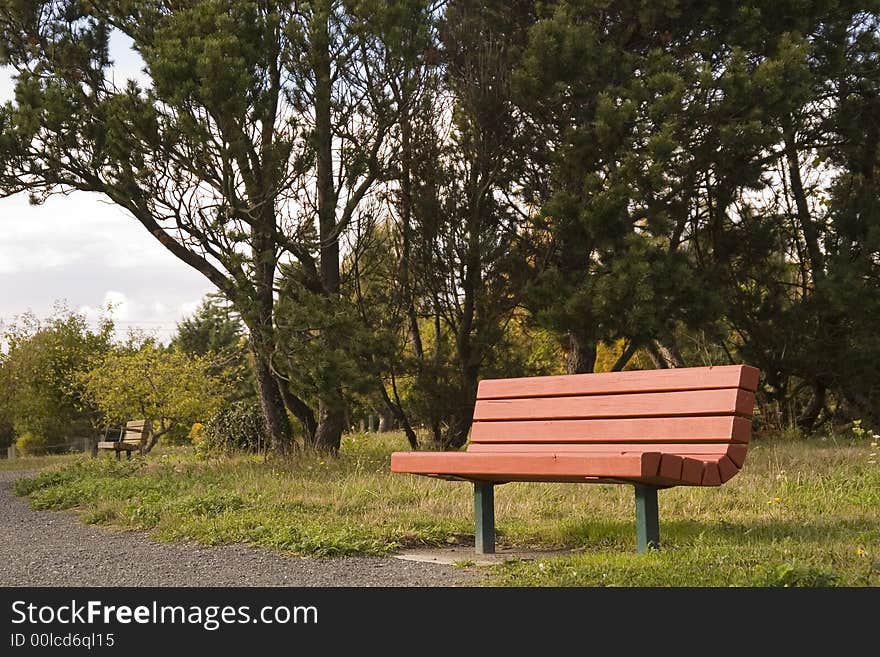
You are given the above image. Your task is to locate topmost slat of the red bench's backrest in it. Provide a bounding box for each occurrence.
[477,365,758,399]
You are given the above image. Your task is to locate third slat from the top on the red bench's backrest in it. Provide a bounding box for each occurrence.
[470,415,752,444]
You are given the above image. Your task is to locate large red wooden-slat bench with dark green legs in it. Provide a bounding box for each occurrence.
[391,365,759,553]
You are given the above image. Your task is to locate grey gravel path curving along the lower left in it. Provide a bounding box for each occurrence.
[0,472,480,586]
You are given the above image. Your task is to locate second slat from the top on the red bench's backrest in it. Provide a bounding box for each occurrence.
[474,388,755,421]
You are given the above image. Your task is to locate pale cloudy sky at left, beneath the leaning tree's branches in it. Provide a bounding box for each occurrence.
[0,29,213,339]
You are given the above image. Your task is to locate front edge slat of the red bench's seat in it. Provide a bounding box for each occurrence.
[391,452,660,478]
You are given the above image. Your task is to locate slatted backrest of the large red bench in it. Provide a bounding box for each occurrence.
[468,365,758,483]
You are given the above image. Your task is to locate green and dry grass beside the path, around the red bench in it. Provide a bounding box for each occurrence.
[6,428,880,586]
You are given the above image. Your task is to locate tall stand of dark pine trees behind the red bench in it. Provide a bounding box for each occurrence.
[0,0,880,452]
